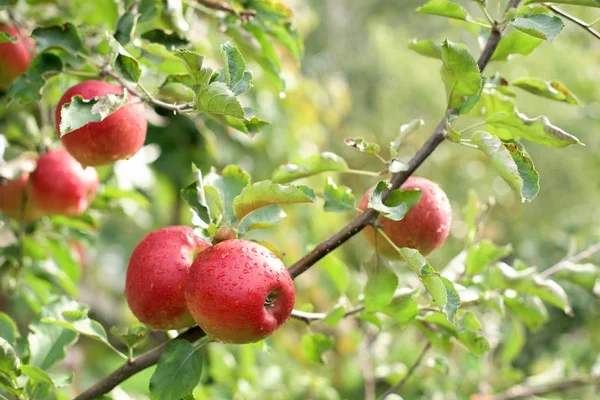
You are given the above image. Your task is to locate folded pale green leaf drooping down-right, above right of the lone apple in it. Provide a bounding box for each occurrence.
[471,131,540,201]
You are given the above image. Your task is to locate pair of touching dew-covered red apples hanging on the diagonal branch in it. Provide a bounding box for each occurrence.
[125,226,295,343]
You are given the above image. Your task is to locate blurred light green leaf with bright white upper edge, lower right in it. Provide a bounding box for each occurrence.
[486,262,572,314]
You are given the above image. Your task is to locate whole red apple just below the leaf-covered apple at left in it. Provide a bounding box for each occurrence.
[29,149,98,215]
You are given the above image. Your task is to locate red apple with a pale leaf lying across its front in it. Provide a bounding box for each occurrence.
[56,81,148,166]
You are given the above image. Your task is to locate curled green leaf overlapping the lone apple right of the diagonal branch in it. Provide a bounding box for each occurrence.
[368,181,421,221]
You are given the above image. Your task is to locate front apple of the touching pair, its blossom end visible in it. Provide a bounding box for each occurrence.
[185,239,295,343]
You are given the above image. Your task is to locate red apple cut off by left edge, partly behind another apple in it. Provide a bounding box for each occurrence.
[0,172,44,221]
